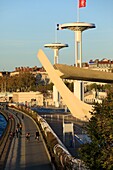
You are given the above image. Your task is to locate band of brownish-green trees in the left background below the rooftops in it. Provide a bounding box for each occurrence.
[0,72,53,93]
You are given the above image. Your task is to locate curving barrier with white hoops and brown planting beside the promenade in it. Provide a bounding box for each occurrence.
[37,112,86,170]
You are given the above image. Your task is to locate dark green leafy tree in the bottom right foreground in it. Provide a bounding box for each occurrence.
[80,91,113,170]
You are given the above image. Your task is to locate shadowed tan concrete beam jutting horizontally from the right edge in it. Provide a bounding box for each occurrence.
[54,64,113,83]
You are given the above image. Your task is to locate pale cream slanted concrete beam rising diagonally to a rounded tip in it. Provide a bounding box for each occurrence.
[37,50,92,120]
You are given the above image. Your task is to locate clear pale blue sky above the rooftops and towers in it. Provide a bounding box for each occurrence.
[0,0,113,71]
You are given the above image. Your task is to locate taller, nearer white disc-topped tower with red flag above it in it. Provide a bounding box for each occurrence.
[60,22,95,101]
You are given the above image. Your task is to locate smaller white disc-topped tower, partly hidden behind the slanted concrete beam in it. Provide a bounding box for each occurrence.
[44,43,68,107]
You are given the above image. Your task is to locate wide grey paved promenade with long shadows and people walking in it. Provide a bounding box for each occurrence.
[5,110,52,170]
